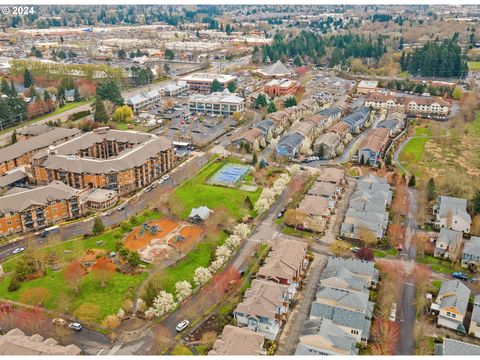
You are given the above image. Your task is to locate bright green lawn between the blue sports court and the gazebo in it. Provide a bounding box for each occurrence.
[174,159,261,220]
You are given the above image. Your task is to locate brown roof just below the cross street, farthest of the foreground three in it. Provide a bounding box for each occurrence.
[258,239,307,280]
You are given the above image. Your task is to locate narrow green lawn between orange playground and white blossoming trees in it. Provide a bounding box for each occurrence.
[158,232,227,294]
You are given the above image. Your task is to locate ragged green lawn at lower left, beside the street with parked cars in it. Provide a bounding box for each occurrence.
[0,269,148,322]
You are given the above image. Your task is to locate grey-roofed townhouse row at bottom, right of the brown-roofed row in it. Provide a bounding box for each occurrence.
[295,257,379,355]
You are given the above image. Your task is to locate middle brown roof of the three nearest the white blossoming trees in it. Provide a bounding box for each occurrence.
[235,279,288,319]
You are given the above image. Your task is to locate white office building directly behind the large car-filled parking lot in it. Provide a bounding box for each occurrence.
[188,89,245,115]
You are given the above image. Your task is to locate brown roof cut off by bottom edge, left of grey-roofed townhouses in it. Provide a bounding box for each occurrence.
[208,325,265,355]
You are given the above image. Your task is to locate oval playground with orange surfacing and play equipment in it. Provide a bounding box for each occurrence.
[124,218,204,263]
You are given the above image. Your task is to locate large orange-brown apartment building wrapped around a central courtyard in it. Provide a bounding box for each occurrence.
[32,128,174,195]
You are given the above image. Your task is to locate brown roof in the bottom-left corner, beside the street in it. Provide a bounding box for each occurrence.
[0,329,81,355]
